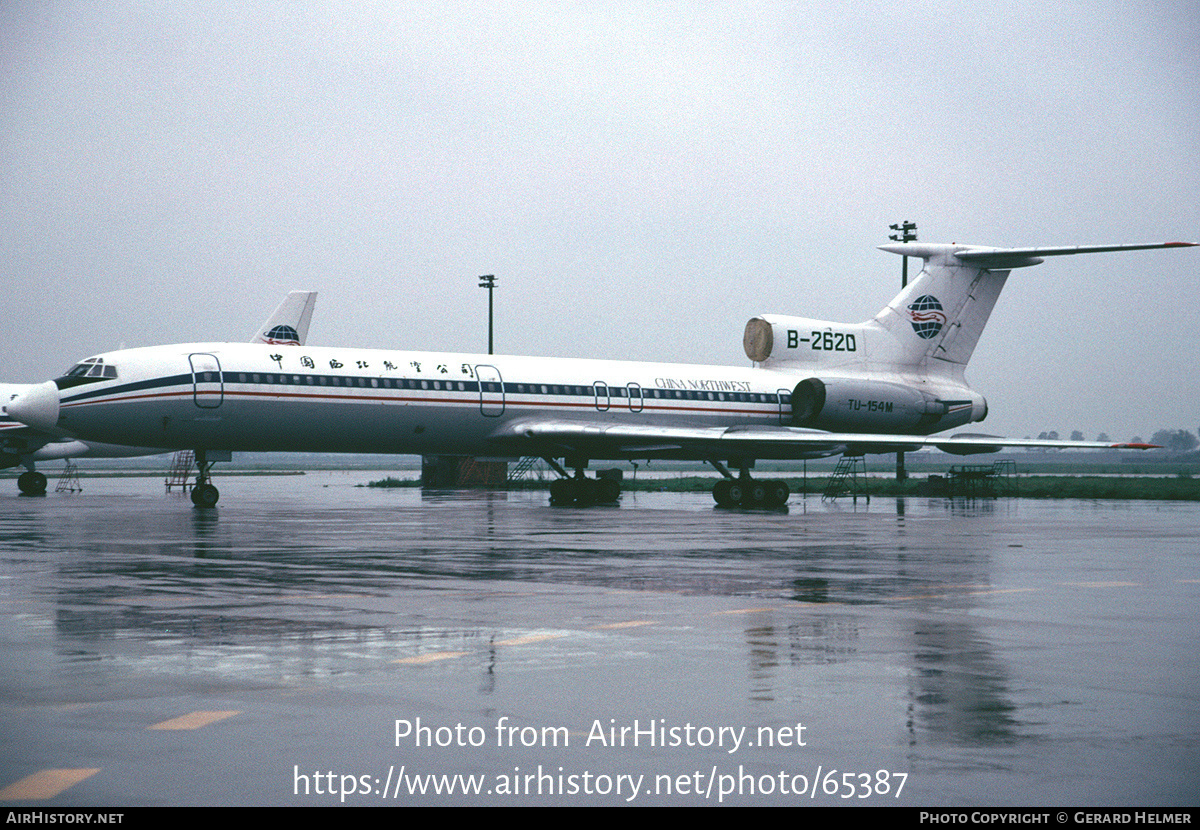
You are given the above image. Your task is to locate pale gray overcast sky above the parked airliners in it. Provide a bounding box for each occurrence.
[0,0,1200,438]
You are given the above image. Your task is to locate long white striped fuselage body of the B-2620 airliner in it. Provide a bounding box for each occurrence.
[49,343,982,458]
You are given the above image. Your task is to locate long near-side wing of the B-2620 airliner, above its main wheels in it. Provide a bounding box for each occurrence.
[492,419,1156,459]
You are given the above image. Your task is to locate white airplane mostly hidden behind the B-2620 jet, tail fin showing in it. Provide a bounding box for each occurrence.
[0,291,317,495]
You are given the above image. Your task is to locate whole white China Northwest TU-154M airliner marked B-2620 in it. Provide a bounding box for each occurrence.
[8,242,1192,507]
